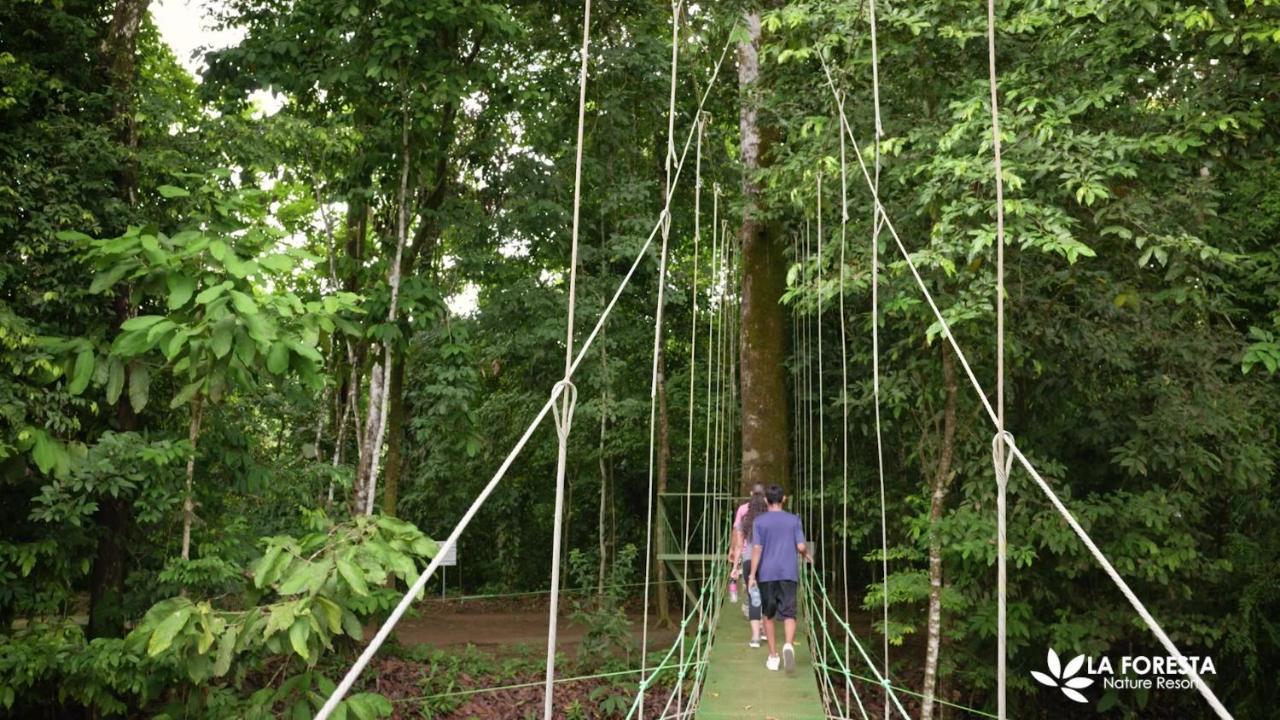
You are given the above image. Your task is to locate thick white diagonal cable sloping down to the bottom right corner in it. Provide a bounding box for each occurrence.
[818,54,1231,719]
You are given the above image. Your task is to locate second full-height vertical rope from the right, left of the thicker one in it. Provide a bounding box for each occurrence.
[865,0,890,717]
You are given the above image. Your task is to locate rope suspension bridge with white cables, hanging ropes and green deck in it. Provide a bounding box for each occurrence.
[316,0,1231,720]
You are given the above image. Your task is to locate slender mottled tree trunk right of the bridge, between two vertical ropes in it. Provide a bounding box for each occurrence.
[920,343,956,720]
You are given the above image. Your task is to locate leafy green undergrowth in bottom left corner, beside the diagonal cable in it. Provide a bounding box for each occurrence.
[0,511,438,720]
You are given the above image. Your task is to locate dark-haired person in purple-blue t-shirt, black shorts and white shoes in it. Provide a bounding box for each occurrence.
[748,484,813,673]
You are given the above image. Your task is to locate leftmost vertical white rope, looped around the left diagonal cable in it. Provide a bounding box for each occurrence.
[543,0,591,720]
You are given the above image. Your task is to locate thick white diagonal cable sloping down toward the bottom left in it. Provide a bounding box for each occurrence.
[315,9,733,720]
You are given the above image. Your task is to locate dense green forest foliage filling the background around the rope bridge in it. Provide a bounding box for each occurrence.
[0,0,1280,719]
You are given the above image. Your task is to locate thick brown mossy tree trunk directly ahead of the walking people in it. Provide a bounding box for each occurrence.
[737,13,790,495]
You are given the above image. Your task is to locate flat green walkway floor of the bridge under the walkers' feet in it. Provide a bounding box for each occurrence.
[696,586,827,720]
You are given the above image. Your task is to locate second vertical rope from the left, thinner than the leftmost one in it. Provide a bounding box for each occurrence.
[639,0,681,720]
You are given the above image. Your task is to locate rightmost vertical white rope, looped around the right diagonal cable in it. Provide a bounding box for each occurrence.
[987,0,1009,720]
